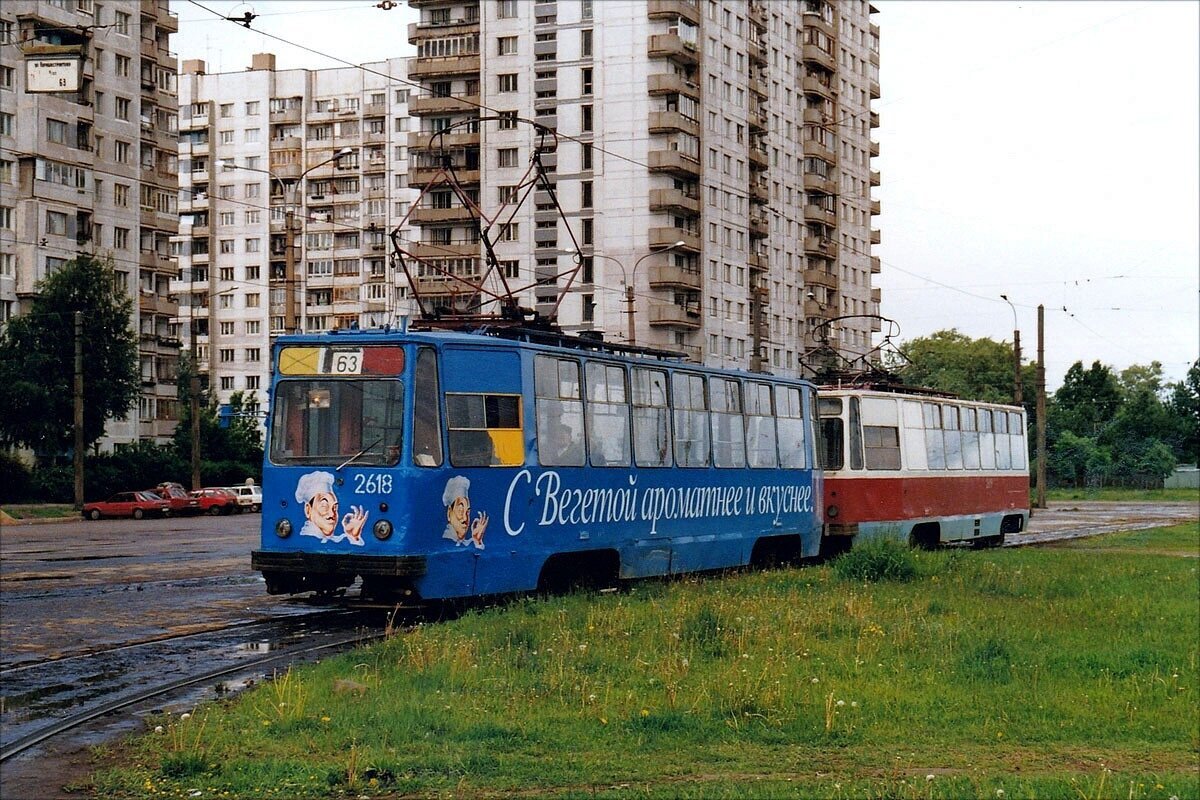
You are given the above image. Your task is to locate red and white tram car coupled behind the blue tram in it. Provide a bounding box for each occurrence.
[818,387,1030,549]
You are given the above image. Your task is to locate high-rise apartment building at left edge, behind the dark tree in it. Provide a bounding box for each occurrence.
[0,0,180,450]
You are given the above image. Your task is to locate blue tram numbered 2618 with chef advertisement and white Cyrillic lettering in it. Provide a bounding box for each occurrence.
[252,330,823,600]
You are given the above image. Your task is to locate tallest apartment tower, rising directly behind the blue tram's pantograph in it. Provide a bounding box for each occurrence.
[408,0,880,374]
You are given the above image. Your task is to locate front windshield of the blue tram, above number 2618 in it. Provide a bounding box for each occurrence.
[271,379,404,467]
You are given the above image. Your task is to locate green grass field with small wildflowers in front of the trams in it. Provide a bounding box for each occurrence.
[85,524,1200,800]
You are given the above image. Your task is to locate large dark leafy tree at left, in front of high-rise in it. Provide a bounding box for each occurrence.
[0,254,138,453]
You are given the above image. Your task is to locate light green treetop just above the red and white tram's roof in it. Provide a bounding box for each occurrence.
[898,329,1033,403]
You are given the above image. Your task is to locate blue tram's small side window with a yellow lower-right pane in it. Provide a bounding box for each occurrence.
[446,393,524,467]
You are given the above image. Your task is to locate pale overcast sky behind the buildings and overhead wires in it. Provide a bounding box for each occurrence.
[172,0,1200,391]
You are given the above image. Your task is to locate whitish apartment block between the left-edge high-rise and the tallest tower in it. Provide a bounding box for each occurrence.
[170,53,415,419]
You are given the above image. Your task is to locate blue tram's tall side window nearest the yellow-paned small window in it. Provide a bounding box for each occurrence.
[533,355,584,467]
